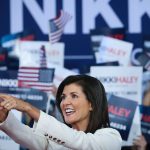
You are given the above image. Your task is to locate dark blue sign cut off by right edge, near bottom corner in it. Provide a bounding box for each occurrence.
[140,105,150,142]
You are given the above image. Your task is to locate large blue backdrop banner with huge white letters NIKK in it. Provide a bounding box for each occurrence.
[0,0,150,71]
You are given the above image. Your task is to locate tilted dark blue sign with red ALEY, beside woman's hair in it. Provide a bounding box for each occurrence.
[108,95,138,141]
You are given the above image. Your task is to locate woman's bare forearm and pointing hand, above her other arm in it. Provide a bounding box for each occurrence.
[0,94,40,121]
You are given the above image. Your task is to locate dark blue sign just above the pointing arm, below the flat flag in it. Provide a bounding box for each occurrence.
[0,87,48,110]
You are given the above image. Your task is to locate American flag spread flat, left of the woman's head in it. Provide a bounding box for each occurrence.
[18,67,54,92]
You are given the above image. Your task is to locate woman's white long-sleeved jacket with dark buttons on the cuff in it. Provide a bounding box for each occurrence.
[0,111,122,150]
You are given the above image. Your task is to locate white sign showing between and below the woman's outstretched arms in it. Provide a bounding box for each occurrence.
[0,110,21,150]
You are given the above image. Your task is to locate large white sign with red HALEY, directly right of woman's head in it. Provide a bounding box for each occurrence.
[90,66,143,145]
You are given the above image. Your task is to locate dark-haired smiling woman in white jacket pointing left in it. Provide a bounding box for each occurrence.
[0,75,122,150]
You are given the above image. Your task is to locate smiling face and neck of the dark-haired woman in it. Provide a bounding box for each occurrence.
[60,83,92,131]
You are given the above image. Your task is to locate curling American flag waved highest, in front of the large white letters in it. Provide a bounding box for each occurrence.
[49,10,72,44]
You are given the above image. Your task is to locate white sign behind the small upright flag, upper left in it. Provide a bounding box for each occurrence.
[14,41,64,67]
